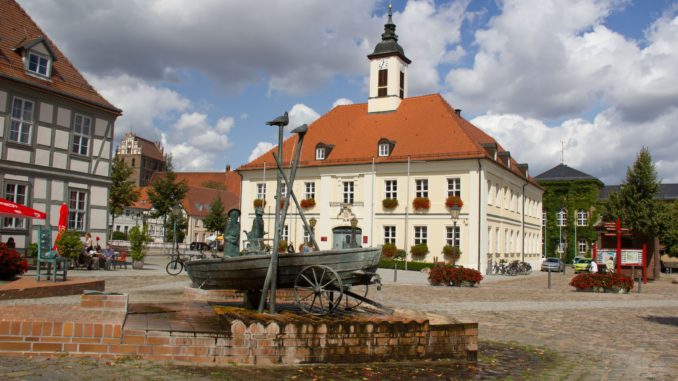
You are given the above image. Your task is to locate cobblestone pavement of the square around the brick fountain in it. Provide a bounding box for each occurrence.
[0,257,678,380]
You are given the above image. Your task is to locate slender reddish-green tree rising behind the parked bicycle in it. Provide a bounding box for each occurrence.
[148,156,188,242]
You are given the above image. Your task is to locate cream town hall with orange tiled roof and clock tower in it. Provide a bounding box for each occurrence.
[238,8,543,271]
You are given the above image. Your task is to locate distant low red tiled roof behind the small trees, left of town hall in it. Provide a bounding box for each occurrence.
[132,185,240,217]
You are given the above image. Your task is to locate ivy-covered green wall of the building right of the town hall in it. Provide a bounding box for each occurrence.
[539,179,603,262]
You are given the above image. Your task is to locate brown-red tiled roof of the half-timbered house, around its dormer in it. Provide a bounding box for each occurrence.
[0,0,122,115]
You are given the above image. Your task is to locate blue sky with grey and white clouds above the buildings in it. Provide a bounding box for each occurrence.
[19,0,678,184]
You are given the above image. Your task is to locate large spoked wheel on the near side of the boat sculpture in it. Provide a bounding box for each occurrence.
[294,265,344,315]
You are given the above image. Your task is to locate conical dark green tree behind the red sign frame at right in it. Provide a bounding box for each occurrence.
[603,147,667,238]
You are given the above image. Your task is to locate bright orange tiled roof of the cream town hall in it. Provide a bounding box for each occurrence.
[238,94,536,184]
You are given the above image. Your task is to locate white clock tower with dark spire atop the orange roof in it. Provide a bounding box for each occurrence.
[367,4,412,113]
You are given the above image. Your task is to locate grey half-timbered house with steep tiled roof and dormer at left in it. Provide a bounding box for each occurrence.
[0,0,122,249]
